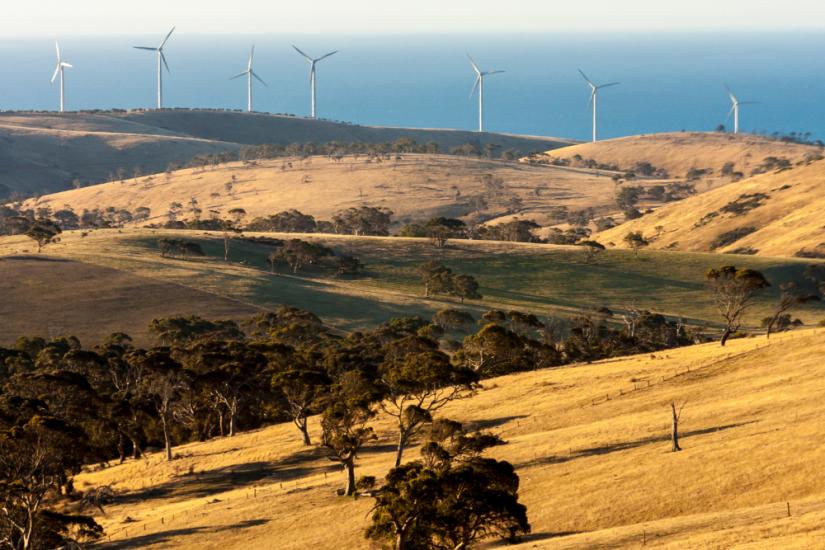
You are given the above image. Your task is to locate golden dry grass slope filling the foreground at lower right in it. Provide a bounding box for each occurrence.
[76,330,825,550]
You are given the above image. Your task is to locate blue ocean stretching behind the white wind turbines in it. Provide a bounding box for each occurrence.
[0,33,825,139]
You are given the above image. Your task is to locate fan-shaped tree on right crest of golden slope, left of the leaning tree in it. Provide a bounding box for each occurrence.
[705,265,771,346]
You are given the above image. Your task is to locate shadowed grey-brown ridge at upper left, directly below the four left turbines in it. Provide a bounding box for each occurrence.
[0,110,572,196]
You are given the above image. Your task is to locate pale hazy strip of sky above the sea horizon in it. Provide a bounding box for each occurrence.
[0,0,825,37]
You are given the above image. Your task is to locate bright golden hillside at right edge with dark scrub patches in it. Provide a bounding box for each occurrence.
[597,156,825,257]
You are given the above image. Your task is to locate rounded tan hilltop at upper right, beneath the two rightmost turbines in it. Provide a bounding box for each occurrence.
[536,132,822,181]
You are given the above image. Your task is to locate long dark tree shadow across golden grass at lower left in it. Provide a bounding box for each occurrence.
[114,447,338,504]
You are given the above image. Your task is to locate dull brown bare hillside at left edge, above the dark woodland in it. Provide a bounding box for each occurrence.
[0,256,258,346]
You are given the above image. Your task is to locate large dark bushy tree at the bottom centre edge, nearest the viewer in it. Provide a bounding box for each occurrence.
[366,420,530,550]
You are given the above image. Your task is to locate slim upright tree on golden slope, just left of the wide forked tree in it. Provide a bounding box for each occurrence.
[321,371,375,496]
